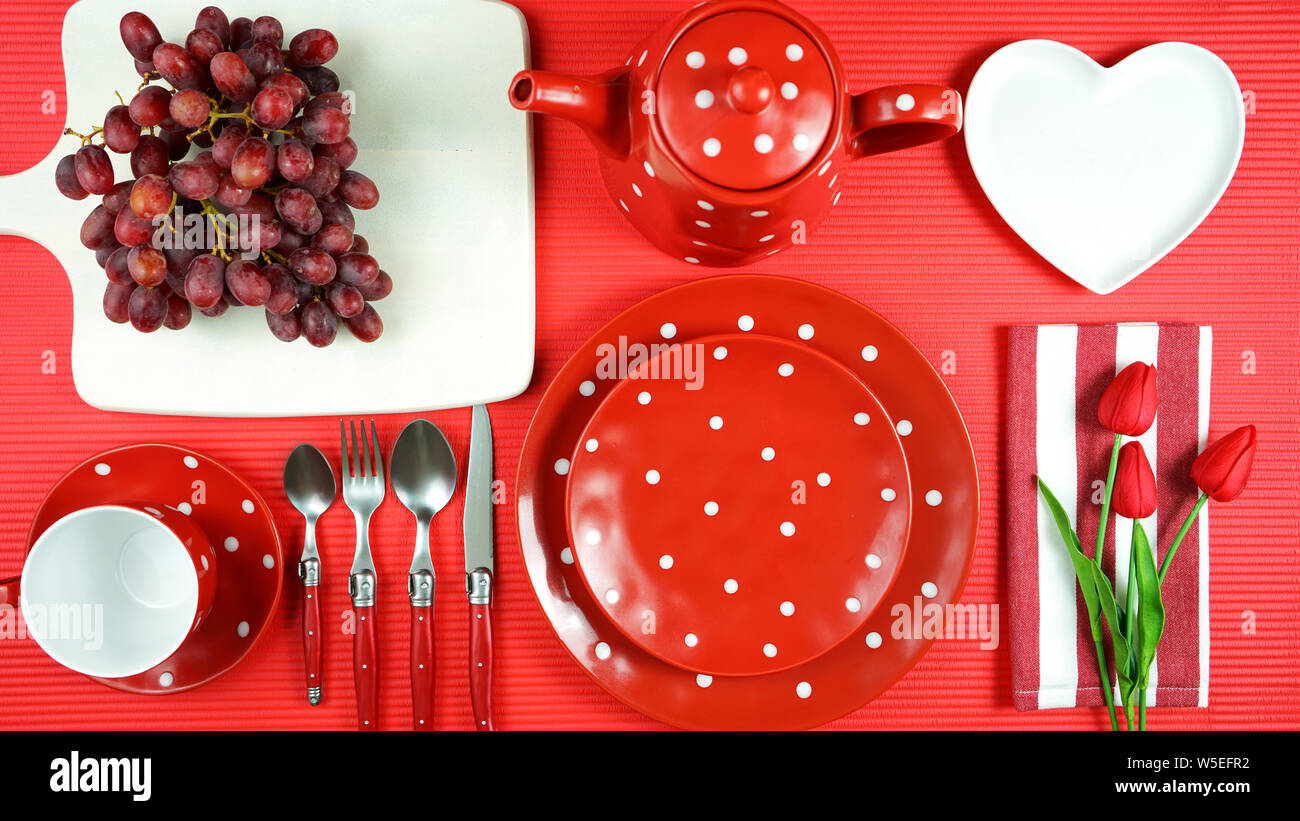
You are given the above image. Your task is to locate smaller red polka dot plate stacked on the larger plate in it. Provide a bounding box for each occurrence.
[568,334,911,676]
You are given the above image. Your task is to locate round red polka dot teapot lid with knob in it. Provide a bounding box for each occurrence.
[655,10,836,191]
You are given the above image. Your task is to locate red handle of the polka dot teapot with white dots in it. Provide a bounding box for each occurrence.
[849,83,962,158]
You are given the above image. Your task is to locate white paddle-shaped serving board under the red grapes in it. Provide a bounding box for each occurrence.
[0,0,534,416]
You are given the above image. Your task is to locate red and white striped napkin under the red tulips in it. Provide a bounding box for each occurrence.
[1006,323,1210,711]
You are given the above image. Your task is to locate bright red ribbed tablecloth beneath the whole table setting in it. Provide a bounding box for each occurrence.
[0,0,1300,729]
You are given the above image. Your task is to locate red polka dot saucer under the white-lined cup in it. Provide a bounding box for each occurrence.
[27,444,283,695]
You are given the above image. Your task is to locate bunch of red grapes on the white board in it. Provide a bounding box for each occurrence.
[55,6,393,348]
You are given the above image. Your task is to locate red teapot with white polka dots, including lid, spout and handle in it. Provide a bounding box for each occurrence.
[510,0,962,266]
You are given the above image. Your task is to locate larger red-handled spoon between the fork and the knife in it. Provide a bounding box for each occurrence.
[389,420,456,730]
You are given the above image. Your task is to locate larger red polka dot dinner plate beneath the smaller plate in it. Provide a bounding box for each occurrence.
[516,275,979,730]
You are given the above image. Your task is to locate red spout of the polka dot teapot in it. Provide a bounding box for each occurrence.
[510,70,632,158]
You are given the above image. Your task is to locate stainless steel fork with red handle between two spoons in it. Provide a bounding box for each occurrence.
[338,420,387,730]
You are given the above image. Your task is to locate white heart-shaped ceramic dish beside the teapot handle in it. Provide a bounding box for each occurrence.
[965,40,1245,294]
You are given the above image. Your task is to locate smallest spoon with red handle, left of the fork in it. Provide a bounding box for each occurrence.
[285,444,337,704]
